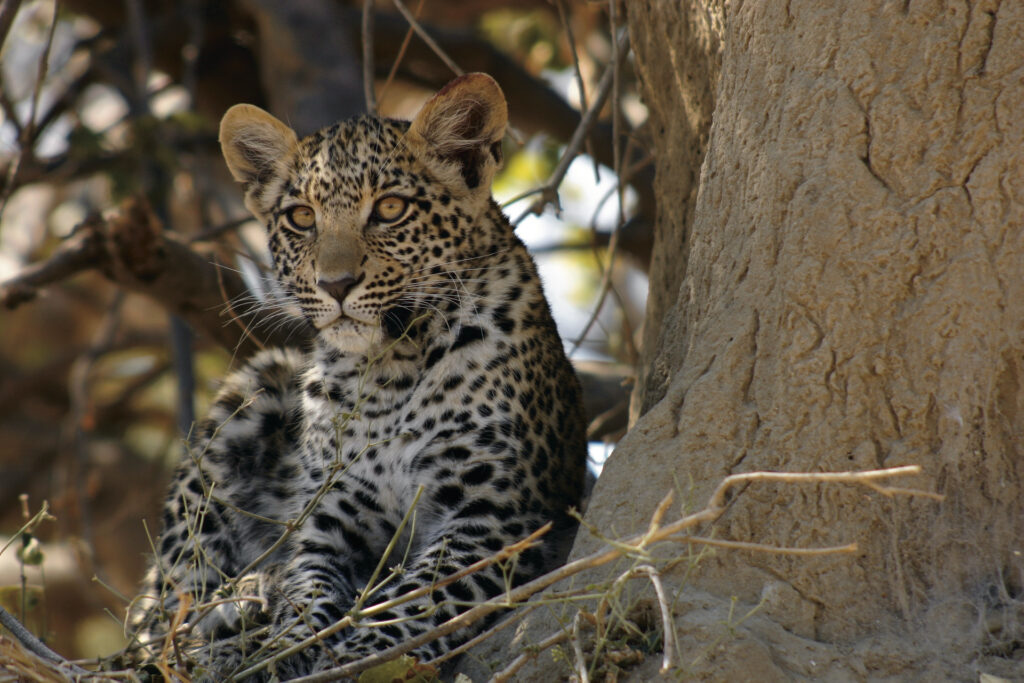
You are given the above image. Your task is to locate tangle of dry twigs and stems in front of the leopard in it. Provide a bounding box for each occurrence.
[0,455,941,683]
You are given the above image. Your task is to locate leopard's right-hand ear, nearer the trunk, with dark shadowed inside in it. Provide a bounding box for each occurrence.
[409,74,509,196]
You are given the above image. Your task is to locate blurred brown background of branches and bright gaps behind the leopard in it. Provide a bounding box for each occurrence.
[0,0,656,657]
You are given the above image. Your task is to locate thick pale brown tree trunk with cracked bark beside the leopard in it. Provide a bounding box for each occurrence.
[573,1,1024,680]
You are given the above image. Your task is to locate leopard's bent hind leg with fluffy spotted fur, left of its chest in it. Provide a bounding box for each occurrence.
[129,351,301,654]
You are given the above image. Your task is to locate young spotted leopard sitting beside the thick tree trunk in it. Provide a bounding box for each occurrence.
[129,74,587,680]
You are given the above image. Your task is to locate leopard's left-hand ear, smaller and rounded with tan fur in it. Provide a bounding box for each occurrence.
[220,104,298,187]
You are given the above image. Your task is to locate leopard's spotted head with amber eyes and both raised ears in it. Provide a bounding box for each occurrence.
[220,74,508,351]
